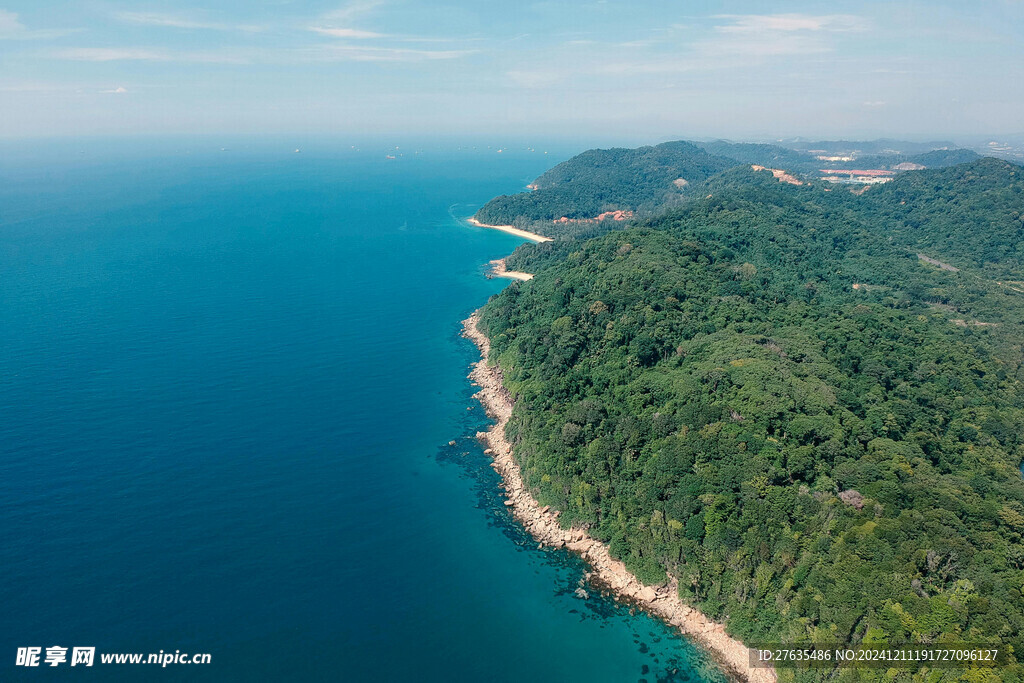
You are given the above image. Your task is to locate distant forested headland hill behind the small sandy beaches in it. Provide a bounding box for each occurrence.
[476,141,736,229]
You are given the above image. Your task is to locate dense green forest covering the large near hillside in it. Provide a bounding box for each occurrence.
[481,159,1024,681]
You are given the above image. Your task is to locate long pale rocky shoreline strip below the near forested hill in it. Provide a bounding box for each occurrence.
[463,313,777,683]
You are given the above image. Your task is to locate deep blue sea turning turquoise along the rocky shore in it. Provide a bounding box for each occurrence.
[0,143,718,682]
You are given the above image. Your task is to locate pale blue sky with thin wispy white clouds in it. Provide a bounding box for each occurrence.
[0,0,1024,141]
